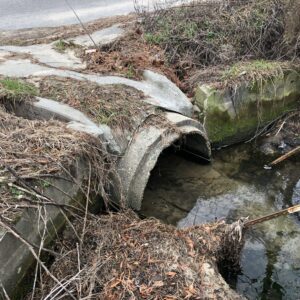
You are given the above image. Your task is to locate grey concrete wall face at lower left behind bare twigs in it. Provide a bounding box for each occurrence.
[0,160,89,299]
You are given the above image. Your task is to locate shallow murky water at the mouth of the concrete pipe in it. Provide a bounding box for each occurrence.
[142,145,300,299]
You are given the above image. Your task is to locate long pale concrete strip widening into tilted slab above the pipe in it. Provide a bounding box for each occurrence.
[0,59,193,117]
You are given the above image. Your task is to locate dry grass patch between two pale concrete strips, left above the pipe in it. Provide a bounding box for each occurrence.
[38,77,150,129]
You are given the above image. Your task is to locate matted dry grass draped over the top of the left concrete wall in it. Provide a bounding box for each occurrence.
[0,106,113,222]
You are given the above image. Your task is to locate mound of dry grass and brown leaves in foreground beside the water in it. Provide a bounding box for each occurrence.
[28,211,244,300]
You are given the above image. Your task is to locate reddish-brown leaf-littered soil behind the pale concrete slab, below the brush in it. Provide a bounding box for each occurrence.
[83,26,190,90]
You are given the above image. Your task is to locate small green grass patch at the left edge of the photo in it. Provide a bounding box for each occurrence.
[0,78,38,99]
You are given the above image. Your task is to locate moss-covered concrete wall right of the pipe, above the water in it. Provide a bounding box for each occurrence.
[195,70,300,145]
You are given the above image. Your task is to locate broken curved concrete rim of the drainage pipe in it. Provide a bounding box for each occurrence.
[115,113,211,210]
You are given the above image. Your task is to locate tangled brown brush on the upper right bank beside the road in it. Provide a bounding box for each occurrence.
[139,0,300,75]
